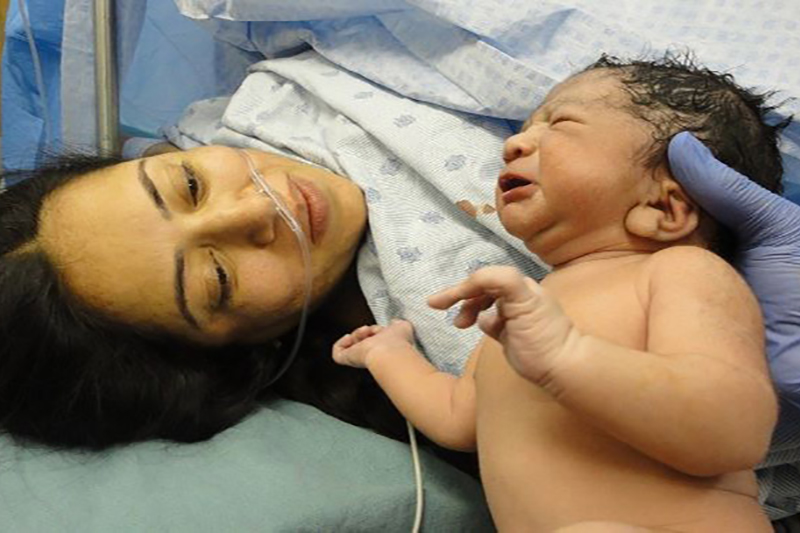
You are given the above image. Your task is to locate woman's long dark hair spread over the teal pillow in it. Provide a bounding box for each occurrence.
[0,155,404,450]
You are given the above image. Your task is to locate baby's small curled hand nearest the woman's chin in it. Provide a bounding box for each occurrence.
[333,320,414,368]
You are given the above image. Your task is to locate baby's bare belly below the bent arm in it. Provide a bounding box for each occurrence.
[478,372,765,533]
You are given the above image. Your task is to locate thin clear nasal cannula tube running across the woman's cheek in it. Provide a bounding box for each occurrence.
[239,150,313,385]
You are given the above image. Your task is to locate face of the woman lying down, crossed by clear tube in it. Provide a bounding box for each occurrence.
[38,147,366,344]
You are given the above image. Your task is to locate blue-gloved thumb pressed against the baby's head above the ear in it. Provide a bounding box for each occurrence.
[668,132,800,242]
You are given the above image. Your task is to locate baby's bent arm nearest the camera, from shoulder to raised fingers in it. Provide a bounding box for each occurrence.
[431,255,776,476]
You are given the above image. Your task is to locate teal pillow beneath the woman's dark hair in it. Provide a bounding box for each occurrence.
[0,400,493,533]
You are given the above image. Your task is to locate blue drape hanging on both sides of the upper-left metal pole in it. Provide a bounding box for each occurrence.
[2,0,253,168]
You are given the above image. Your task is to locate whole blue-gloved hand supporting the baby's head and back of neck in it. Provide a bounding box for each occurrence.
[669,132,800,409]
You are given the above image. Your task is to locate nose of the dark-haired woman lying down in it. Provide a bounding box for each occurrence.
[201,191,279,246]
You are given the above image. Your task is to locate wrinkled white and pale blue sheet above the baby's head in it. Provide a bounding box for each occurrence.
[170,0,800,201]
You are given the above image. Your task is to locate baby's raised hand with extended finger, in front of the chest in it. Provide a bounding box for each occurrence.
[428,266,578,385]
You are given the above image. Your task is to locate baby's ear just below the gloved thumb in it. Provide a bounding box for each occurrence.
[625,164,700,243]
